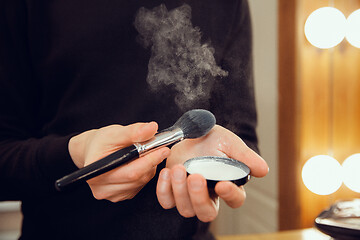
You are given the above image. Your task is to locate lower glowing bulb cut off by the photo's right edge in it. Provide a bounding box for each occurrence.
[342,153,360,193]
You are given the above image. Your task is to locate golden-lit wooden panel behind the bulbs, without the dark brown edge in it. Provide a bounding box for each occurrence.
[298,0,360,228]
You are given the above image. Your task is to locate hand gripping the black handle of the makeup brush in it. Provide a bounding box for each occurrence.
[68,122,170,202]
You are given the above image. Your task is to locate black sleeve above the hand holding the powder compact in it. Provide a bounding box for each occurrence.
[212,0,258,152]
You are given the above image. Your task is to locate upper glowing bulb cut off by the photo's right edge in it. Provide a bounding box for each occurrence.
[345,9,360,48]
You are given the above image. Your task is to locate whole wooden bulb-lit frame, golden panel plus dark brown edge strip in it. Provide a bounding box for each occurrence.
[278,0,360,230]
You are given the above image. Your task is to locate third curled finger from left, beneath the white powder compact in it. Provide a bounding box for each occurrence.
[187,174,219,222]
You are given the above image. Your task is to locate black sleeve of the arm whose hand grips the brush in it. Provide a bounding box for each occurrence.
[0,0,76,200]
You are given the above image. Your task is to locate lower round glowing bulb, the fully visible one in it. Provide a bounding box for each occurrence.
[302,155,342,195]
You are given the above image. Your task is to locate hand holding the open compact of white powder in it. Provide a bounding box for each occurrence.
[157,125,268,222]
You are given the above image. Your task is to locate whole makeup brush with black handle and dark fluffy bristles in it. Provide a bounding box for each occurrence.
[55,109,216,191]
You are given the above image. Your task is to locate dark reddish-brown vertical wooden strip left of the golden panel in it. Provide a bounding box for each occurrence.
[278,0,301,230]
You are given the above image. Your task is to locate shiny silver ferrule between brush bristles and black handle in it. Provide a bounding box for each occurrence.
[134,128,184,156]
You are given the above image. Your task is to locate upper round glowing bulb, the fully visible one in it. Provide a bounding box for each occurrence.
[304,7,346,49]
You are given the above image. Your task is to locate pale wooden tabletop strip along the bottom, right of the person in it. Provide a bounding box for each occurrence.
[216,228,331,240]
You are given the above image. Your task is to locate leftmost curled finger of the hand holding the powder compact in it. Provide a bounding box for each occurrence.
[156,168,175,209]
